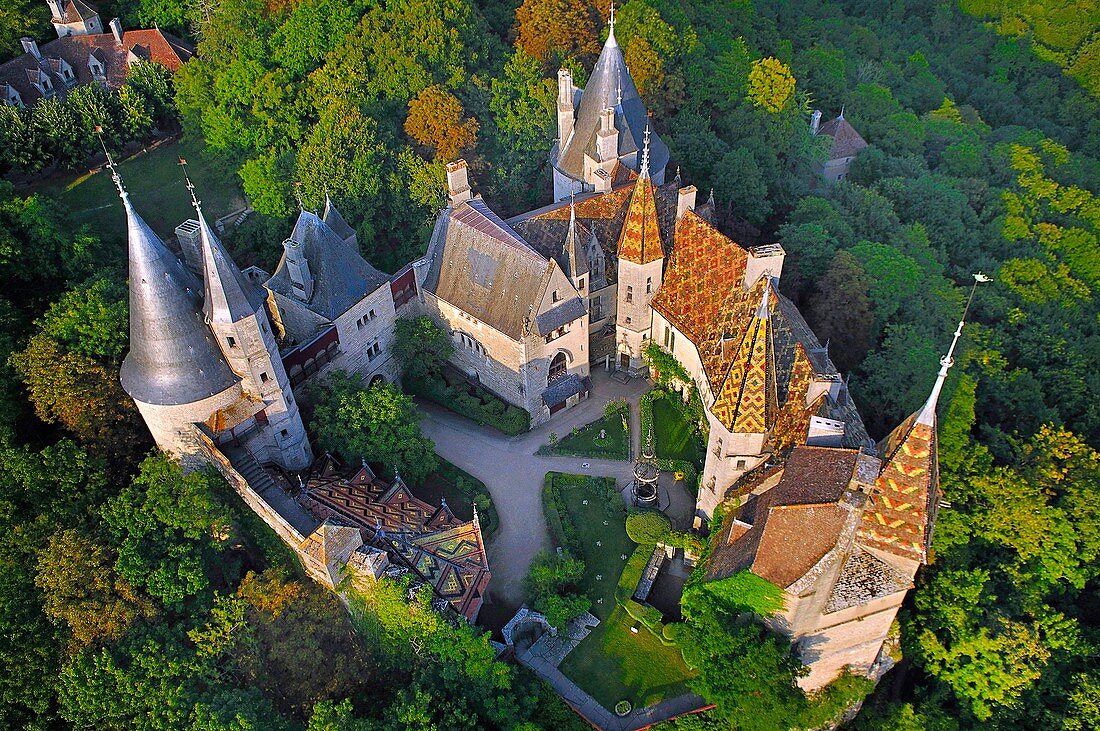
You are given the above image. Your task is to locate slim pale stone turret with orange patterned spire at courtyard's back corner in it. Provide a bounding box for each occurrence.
[615,128,664,370]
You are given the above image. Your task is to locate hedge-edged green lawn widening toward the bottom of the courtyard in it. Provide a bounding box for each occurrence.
[550,477,691,709]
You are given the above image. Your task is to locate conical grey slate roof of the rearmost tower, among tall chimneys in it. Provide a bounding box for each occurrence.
[556,34,669,180]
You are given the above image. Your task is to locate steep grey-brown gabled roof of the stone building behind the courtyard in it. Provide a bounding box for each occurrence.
[425,198,551,341]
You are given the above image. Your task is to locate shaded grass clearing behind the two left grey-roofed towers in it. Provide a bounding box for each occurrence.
[40,140,245,244]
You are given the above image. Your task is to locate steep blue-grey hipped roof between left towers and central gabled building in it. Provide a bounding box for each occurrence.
[266,211,389,321]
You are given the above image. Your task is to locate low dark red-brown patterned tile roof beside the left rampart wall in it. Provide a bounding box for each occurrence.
[303,458,491,620]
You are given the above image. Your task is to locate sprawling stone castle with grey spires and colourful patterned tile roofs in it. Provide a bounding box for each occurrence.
[119,14,946,689]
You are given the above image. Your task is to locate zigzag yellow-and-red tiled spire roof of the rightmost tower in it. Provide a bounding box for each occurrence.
[859,413,939,562]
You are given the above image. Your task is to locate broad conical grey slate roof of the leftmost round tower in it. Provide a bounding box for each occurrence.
[120,195,238,406]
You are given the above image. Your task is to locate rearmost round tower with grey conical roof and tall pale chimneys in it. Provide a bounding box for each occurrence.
[550,8,669,200]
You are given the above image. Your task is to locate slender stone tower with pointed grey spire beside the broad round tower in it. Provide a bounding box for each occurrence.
[188,181,314,469]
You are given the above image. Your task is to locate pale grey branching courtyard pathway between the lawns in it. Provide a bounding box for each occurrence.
[419,370,649,608]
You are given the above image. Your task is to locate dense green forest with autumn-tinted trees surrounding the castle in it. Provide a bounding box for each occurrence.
[0,0,1100,731]
